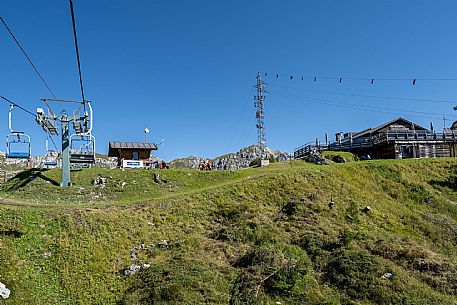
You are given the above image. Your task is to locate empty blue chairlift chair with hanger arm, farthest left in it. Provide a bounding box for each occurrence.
[6,104,32,159]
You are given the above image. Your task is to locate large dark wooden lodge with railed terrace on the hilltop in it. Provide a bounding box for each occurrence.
[294,117,457,159]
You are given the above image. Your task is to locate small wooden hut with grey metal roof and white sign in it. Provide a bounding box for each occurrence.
[108,142,157,168]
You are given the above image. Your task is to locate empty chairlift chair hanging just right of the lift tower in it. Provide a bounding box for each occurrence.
[70,133,95,164]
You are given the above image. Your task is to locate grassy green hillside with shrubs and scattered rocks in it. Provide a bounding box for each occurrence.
[0,159,457,304]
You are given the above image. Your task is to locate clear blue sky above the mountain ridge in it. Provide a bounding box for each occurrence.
[0,0,457,160]
